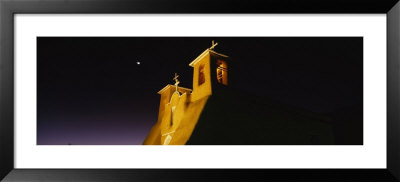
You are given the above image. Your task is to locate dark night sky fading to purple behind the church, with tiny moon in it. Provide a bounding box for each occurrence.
[37,37,363,145]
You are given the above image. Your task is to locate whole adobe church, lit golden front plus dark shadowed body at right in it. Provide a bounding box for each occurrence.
[143,42,334,145]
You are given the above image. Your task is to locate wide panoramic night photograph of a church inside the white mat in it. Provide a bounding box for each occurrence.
[36,37,363,145]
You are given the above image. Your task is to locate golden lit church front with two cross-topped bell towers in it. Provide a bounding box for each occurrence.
[144,41,228,145]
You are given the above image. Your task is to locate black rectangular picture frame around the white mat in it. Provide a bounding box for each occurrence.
[0,0,400,181]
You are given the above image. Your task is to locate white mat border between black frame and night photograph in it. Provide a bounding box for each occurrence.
[15,14,386,168]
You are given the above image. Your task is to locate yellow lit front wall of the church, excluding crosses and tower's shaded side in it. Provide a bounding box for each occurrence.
[143,50,212,145]
